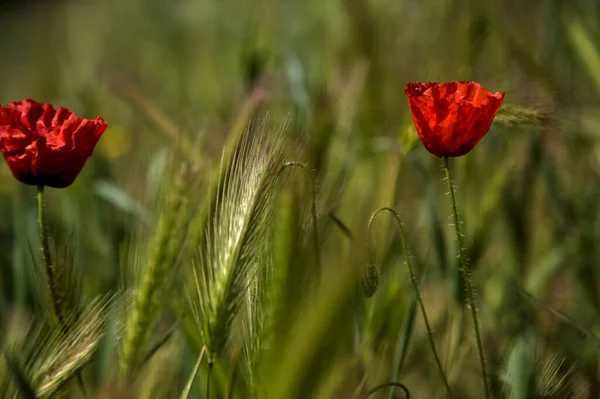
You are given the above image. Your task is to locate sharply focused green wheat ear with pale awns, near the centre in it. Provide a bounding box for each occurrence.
[188,118,285,359]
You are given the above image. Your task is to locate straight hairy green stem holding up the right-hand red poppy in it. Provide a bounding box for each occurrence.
[444,157,491,399]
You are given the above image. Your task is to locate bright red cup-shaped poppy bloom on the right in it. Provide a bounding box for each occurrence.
[404,82,505,157]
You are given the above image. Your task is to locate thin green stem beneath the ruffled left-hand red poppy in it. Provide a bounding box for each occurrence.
[37,185,87,397]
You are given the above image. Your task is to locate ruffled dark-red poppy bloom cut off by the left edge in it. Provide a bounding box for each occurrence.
[0,100,106,188]
